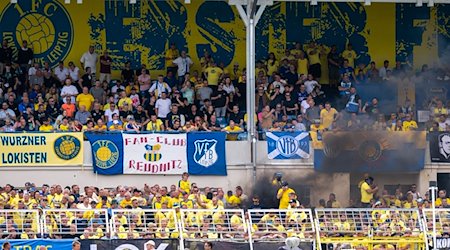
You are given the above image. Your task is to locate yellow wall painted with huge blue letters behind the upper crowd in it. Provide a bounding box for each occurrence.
[0,0,450,79]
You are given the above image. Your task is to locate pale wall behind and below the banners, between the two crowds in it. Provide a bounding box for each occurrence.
[0,141,450,205]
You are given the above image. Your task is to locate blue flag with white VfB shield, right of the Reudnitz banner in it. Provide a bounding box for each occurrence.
[187,132,227,175]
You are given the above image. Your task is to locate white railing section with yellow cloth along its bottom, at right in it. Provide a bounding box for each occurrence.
[315,208,427,249]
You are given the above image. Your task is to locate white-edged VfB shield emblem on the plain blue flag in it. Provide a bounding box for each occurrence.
[194,140,219,168]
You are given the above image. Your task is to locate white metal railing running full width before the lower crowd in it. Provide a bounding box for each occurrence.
[0,208,450,250]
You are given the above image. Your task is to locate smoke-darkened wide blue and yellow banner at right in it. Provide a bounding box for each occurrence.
[311,131,426,173]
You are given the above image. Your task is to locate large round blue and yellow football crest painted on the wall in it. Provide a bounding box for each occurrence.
[0,0,73,67]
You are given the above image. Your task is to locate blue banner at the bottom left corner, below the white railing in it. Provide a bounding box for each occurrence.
[0,239,73,250]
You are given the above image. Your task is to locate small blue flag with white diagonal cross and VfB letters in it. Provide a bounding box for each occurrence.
[266,132,309,160]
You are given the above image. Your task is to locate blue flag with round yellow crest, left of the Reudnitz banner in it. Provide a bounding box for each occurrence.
[85,132,123,175]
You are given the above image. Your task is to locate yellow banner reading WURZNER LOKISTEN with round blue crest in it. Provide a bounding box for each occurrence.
[0,133,83,167]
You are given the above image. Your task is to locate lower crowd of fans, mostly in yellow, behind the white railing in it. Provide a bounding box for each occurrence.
[0,173,450,240]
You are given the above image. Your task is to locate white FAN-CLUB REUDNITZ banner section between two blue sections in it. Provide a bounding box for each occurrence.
[123,134,187,174]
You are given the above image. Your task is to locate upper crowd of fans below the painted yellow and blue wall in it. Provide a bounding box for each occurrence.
[0,41,450,137]
